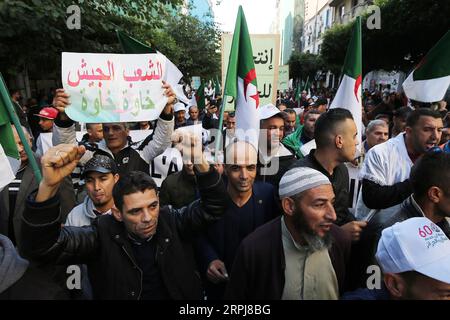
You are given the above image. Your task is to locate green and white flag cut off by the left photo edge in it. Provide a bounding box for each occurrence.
[0,89,20,190]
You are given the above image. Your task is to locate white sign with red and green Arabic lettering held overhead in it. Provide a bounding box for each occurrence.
[62,52,167,123]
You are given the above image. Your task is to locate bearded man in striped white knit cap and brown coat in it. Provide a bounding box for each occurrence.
[225,167,351,300]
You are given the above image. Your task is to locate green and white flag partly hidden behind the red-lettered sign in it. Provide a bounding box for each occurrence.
[116,30,189,104]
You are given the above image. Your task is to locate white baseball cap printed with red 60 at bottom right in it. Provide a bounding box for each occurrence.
[375,218,450,283]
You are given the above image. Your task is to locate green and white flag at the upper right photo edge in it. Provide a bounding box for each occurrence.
[403,31,450,102]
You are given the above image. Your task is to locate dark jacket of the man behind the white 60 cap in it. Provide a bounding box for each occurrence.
[350,195,450,288]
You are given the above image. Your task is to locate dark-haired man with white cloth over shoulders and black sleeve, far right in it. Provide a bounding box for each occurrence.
[356,108,444,220]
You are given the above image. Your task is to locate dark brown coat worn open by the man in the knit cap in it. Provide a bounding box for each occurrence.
[225,217,351,300]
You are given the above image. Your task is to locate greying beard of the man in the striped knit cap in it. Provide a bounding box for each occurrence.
[292,208,332,252]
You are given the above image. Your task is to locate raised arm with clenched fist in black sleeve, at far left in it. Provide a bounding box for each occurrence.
[21,144,98,264]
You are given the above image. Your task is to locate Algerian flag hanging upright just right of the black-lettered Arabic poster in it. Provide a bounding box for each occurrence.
[330,17,362,145]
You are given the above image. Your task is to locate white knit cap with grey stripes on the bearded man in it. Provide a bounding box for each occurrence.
[279,167,331,199]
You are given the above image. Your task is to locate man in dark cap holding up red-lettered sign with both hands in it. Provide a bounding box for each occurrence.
[49,84,175,175]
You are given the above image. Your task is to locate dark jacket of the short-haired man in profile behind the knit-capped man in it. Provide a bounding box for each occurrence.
[289,149,356,226]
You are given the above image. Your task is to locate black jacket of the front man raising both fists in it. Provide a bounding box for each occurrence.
[22,170,226,299]
